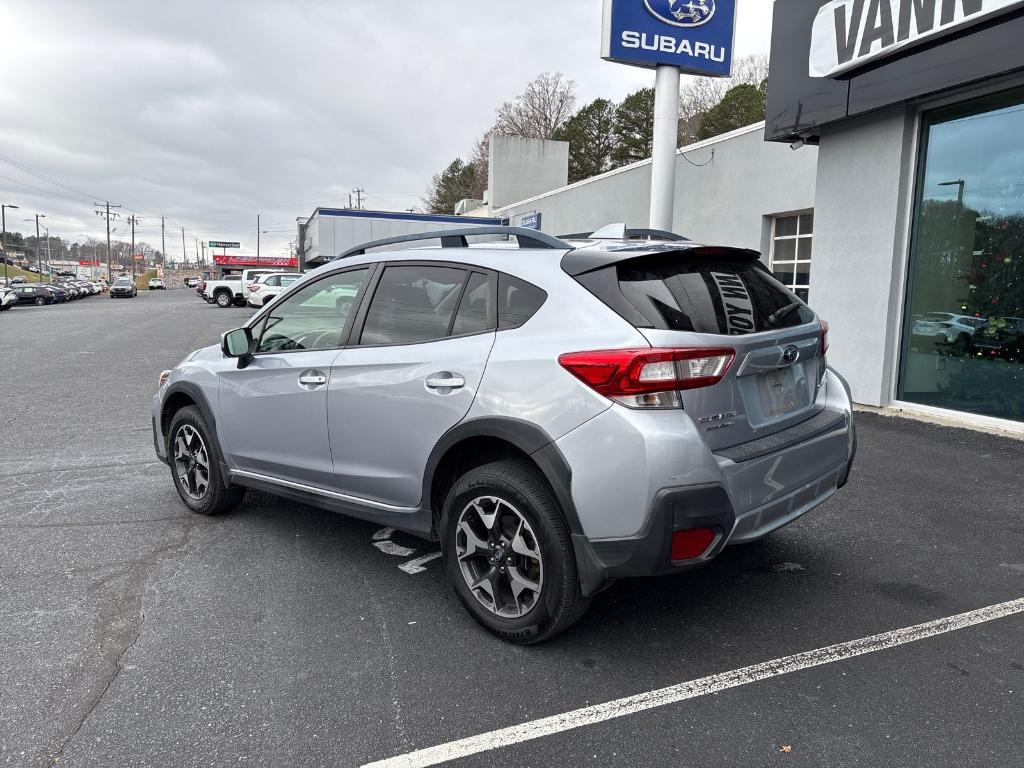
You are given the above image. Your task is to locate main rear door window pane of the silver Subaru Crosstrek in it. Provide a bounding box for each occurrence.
[359,266,466,344]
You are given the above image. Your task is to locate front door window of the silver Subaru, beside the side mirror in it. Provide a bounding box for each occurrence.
[257,267,370,352]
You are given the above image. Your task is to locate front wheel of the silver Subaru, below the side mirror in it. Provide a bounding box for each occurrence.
[167,406,246,515]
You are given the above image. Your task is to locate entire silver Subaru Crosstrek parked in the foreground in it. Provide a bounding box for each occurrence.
[153,225,856,643]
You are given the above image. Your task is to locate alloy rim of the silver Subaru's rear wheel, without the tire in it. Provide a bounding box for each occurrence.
[455,496,544,618]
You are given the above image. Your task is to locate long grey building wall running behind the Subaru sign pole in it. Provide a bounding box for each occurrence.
[495,123,817,251]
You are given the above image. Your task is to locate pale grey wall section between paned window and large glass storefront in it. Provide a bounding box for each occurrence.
[811,106,914,406]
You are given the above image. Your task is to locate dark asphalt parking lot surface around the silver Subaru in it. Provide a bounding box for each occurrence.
[0,290,1024,768]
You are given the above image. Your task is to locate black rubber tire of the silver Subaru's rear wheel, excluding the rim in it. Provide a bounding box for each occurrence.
[440,460,590,645]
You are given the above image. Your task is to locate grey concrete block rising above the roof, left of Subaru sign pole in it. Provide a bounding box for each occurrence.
[487,136,569,208]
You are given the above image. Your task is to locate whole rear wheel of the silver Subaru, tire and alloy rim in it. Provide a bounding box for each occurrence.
[441,461,590,645]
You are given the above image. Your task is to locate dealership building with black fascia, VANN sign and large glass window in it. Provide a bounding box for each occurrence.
[765,0,1024,429]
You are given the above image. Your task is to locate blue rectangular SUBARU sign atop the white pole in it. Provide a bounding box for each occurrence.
[601,0,736,77]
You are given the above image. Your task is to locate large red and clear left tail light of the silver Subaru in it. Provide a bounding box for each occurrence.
[558,348,735,408]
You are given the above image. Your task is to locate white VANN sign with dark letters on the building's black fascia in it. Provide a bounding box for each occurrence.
[808,0,1024,78]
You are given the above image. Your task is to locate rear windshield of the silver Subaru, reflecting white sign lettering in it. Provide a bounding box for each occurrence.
[578,254,814,336]
